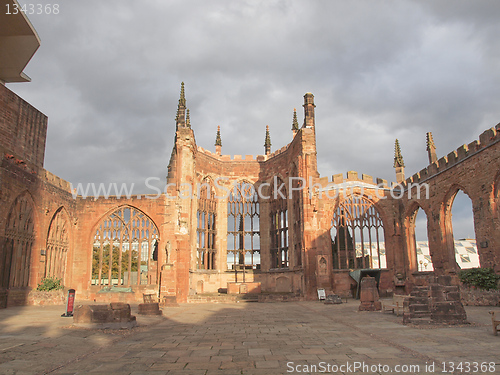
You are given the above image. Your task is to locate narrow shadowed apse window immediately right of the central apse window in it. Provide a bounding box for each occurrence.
[269,178,289,268]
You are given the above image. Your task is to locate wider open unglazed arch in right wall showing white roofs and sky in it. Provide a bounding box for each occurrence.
[451,190,480,269]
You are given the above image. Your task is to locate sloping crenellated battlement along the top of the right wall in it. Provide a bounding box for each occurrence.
[403,124,500,185]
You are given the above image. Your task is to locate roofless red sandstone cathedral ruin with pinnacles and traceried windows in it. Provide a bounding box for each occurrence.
[0,14,500,307]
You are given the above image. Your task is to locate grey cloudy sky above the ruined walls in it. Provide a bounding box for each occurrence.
[8,0,500,241]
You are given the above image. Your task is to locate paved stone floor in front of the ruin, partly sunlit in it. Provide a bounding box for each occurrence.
[0,300,500,375]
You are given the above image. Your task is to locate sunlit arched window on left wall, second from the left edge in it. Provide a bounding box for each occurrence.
[45,208,69,282]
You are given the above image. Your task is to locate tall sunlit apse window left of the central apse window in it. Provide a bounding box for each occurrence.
[196,180,217,270]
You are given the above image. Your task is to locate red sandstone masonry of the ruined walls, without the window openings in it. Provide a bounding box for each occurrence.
[0,87,500,305]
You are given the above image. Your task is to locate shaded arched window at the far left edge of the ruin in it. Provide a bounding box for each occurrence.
[0,194,35,288]
